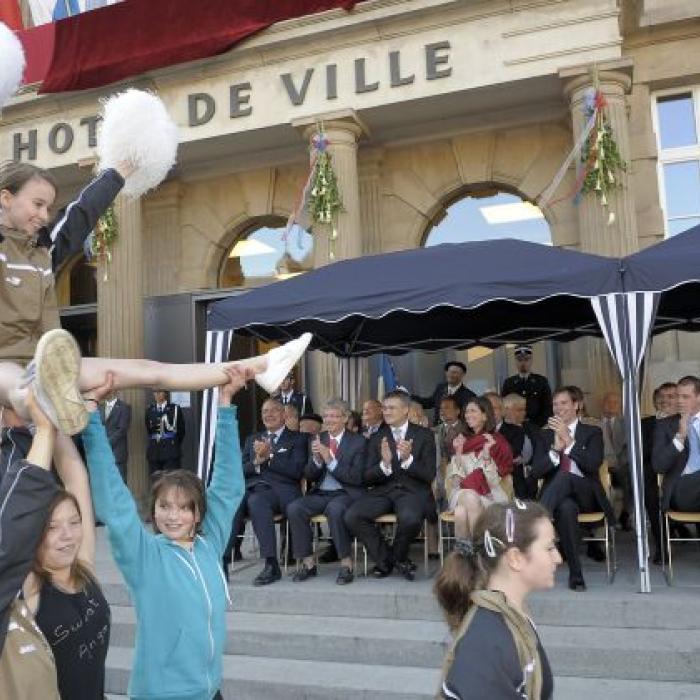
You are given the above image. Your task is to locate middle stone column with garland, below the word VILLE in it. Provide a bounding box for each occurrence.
[292,110,366,408]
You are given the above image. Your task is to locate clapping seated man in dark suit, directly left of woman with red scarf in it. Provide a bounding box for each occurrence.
[345,391,435,581]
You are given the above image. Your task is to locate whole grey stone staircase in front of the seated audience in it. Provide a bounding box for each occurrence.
[98,541,700,700]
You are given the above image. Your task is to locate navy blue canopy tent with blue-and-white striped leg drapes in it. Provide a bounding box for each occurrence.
[200,226,700,592]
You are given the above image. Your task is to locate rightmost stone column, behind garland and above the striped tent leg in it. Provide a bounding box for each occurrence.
[559,59,639,413]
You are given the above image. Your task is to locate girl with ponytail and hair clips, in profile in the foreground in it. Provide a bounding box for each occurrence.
[434,500,561,700]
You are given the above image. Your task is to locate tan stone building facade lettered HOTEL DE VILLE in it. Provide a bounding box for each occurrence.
[0,0,700,492]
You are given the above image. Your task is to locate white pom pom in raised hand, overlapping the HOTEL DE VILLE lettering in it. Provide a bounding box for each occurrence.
[97,88,179,197]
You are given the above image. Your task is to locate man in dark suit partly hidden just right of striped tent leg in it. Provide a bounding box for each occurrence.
[642,382,678,565]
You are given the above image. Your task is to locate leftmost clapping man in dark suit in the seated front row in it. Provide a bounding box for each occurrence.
[224,399,307,586]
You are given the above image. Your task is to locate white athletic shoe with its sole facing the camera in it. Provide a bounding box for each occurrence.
[22,328,88,435]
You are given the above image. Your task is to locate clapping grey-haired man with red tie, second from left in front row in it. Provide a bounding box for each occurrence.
[287,399,367,585]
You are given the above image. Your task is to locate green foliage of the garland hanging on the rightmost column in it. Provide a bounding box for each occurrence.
[581,110,627,207]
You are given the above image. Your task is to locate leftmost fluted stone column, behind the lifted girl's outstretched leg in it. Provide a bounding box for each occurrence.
[97,195,148,498]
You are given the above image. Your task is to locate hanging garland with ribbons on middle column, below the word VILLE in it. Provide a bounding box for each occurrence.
[284,124,345,260]
